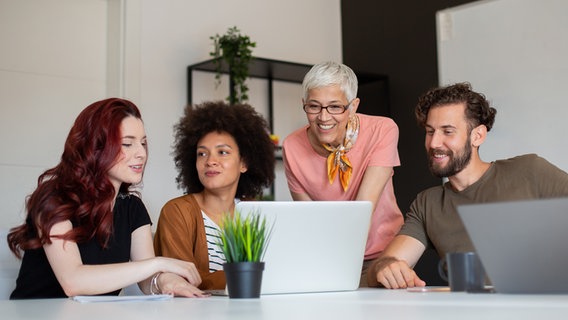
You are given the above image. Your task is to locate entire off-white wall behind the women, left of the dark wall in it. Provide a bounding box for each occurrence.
[0,0,342,228]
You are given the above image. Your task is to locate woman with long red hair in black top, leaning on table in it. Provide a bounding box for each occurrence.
[8,98,204,299]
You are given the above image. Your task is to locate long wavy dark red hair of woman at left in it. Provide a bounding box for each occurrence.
[7,98,142,257]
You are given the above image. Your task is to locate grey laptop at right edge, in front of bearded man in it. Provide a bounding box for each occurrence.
[458,198,568,293]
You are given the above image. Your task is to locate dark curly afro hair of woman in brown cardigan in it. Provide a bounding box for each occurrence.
[172,101,275,199]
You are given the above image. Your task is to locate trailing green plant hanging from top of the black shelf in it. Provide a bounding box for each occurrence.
[209,26,256,104]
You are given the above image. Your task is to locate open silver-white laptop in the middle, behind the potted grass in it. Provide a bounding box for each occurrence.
[213,201,372,295]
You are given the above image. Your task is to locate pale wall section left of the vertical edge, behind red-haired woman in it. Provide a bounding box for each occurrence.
[0,0,107,228]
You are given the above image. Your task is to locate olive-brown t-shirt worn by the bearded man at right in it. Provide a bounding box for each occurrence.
[399,154,568,257]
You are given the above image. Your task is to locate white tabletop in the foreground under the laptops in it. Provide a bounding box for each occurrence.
[0,289,568,320]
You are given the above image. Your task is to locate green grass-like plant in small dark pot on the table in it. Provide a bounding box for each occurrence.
[219,211,272,298]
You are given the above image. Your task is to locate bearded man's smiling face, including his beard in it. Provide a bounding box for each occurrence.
[425,103,472,177]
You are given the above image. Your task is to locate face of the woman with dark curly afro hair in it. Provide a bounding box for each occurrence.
[195,132,247,197]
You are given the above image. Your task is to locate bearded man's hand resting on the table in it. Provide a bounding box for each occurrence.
[374,257,426,289]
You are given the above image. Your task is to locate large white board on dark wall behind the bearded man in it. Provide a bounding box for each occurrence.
[437,0,568,170]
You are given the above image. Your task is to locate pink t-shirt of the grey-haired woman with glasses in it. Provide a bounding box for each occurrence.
[283,113,403,260]
